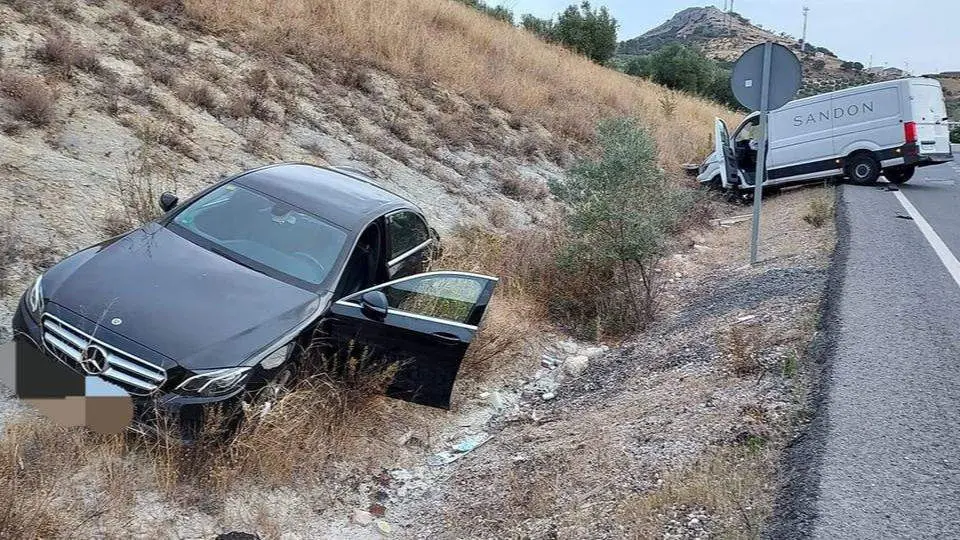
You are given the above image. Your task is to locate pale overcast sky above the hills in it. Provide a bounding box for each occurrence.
[502,0,960,75]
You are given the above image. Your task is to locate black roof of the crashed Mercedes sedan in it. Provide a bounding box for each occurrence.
[233,163,422,232]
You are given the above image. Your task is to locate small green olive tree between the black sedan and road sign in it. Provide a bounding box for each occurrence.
[550,118,689,325]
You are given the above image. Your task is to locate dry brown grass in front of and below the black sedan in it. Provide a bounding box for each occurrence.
[0,340,395,538]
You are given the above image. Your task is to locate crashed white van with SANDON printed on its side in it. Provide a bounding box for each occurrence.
[697,77,953,189]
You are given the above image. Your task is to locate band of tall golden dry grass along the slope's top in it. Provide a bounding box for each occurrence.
[135,0,730,169]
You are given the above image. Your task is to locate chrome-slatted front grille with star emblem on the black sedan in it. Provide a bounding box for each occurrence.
[43,315,167,396]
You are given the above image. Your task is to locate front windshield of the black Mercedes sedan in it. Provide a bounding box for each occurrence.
[170,184,347,289]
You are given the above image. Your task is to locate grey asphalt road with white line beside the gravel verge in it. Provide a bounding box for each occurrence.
[773,155,960,539]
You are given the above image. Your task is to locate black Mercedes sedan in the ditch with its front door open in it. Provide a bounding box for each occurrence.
[14,163,497,428]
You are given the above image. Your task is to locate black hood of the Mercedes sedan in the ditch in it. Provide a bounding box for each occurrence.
[43,224,321,370]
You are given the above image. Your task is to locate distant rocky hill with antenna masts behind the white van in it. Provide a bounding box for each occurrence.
[617,6,902,95]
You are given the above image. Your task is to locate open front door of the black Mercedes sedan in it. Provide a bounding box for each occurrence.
[326,271,497,409]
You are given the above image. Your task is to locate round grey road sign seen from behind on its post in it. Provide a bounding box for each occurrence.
[730,43,801,111]
